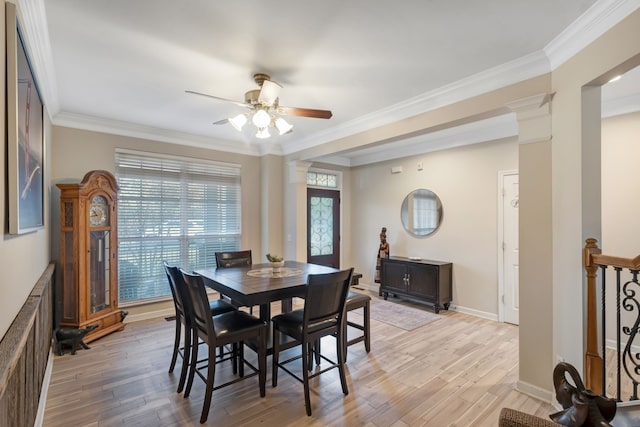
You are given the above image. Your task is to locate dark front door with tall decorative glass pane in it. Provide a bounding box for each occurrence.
[307,188,340,268]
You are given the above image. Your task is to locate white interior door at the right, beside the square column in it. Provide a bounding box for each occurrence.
[502,172,520,325]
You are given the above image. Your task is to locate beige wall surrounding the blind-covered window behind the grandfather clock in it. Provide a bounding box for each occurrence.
[50,126,264,319]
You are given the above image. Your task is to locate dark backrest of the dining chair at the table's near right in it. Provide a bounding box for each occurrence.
[304,268,353,325]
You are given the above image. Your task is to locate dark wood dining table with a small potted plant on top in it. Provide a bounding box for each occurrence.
[196,261,337,322]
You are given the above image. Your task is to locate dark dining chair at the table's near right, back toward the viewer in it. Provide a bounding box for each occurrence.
[271,268,353,415]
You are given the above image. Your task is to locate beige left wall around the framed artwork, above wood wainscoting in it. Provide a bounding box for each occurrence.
[0,3,51,339]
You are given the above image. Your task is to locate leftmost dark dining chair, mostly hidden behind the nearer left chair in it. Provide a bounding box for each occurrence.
[162,261,236,393]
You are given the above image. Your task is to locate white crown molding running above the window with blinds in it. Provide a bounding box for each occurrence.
[52,113,263,156]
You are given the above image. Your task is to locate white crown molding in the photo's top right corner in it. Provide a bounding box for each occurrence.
[544,0,640,70]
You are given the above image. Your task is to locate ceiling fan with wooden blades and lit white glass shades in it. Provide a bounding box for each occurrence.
[185,73,333,138]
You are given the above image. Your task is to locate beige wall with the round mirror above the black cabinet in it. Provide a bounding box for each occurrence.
[351,140,518,319]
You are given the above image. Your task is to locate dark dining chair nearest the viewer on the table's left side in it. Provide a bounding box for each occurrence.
[180,270,267,423]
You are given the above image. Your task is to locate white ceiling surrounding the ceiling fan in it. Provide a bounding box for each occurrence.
[19,0,640,165]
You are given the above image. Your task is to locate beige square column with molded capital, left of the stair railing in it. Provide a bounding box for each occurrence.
[507,94,555,397]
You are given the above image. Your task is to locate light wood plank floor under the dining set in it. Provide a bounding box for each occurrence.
[44,293,555,427]
